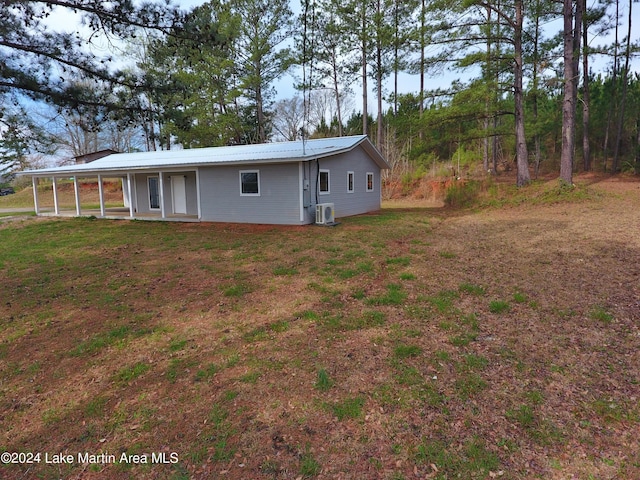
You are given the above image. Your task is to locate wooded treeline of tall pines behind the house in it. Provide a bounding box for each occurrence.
[0,0,640,185]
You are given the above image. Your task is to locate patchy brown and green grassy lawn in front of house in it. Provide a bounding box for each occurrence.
[0,177,640,480]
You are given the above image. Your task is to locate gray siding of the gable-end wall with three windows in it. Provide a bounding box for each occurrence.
[305,147,381,222]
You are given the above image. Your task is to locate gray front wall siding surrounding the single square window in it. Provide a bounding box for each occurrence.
[199,163,302,225]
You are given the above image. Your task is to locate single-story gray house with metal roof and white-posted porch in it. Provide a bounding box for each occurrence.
[21,135,389,225]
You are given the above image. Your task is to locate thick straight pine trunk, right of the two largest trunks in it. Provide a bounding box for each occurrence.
[560,0,576,185]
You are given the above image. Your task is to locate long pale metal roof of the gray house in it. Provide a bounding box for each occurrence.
[21,135,389,176]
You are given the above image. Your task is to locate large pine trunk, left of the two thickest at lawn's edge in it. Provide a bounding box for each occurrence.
[514,0,531,187]
